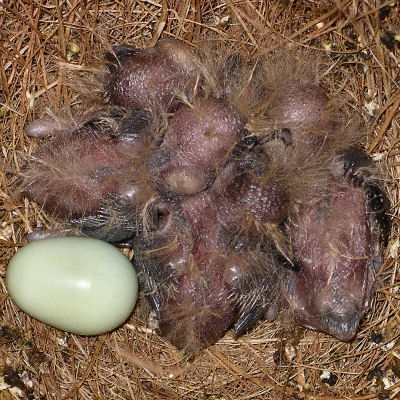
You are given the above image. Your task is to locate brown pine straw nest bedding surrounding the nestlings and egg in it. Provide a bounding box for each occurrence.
[0,0,400,400]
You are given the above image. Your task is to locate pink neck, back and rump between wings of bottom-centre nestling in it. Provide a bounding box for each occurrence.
[156,195,235,353]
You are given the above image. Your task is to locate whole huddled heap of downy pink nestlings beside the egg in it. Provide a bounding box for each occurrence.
[20,39,390,354]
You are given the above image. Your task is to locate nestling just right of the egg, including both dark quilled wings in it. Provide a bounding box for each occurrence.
[135,192,278,354]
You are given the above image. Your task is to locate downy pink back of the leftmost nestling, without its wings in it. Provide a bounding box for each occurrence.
[25,132,130,218]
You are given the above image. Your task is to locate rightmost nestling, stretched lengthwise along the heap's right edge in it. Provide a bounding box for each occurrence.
[260,73,390,341]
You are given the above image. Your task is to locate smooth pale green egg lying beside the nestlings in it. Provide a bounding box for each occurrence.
[6,237,138,335]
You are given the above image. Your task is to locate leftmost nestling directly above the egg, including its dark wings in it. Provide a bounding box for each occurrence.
[20,108,155,242]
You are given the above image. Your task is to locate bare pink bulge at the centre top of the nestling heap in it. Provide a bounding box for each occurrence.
[153,98,244,195]
